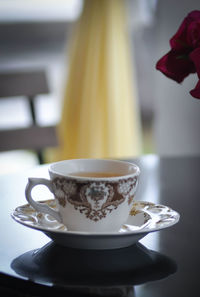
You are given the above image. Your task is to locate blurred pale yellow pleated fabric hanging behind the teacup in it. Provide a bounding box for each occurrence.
[54,0,141,161]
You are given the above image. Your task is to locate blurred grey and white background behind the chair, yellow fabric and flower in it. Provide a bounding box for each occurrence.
[0,0,200,174]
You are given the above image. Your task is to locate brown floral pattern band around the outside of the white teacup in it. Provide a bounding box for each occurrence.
[53,177,137,222]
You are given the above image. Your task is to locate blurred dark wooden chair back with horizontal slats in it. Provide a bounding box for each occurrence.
[0,70,58,164]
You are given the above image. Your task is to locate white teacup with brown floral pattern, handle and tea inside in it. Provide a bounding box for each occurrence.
[25,159,140,232]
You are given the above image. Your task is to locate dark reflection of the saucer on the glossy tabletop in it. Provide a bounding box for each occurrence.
[11,242,177,296]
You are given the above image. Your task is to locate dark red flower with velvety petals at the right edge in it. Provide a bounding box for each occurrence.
[156,10,200,99]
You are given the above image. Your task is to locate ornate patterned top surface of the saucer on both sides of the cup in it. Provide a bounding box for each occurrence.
[12,199,179,234]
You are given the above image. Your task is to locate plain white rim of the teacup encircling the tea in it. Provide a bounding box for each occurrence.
[49,158,140,181]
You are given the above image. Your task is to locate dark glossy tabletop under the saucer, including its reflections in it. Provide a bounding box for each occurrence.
[0,156,200,297]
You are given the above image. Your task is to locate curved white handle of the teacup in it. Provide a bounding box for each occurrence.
[25,177,62,223]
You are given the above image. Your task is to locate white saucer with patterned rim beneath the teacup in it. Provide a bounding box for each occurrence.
[11,200,180,249]
